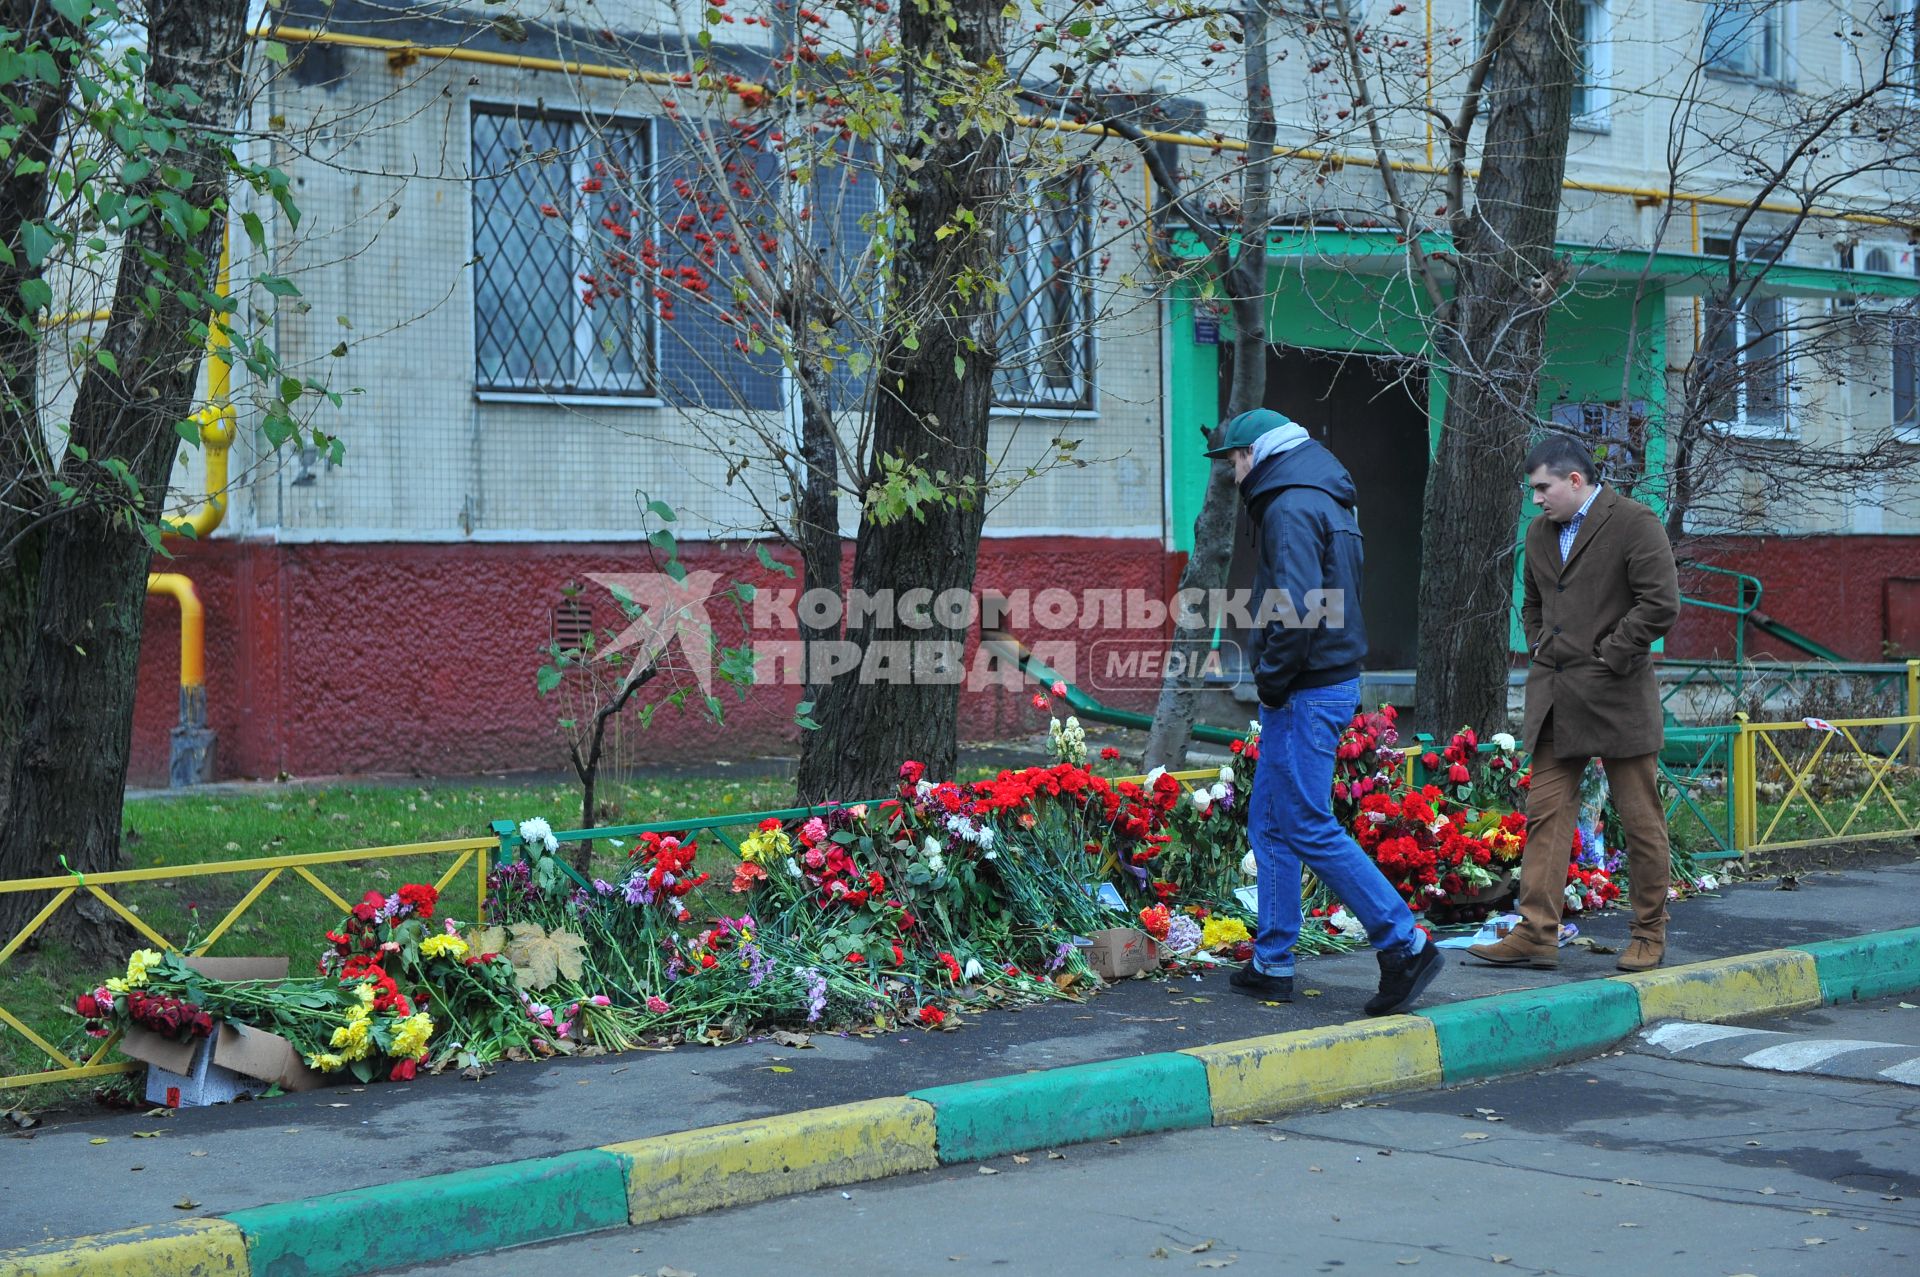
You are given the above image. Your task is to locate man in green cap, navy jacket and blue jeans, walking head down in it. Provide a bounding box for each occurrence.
[1208,409,1444,1016]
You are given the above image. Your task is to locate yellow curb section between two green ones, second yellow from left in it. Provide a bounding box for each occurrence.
[603,1098,939,1223]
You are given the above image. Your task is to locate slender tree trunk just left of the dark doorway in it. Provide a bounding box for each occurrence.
[1146,0,1279,768]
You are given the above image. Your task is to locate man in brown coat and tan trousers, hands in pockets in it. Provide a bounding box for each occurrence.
[1467,436,1680,972]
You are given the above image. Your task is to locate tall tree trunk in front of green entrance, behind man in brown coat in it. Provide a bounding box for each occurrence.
[1415,0,1580,734]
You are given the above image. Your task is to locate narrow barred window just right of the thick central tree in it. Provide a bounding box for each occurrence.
[993,179,1092,411]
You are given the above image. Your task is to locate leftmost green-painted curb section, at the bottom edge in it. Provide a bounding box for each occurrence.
[227,1148,626,1277]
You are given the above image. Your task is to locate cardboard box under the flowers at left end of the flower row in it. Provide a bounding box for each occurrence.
[119,958,326,1108]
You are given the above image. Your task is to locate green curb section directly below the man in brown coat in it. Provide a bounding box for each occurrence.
[1413,979,1640,1087]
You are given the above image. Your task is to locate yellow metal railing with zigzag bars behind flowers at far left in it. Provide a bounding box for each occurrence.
[0,837,497,1087]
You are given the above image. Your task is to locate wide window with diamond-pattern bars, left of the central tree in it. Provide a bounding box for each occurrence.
[472,104,659,399]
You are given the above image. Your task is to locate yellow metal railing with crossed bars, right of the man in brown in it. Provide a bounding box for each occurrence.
[1730,710,1920,851]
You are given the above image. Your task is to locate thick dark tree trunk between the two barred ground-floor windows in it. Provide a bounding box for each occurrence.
[797,0,1008,803]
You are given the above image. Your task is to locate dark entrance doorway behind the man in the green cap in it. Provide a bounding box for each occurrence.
[1229,346,1428,670]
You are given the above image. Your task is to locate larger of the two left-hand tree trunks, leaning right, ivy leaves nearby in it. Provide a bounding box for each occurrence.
[0,0,246,943]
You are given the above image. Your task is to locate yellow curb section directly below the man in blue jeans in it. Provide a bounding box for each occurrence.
[1181,1016,1440,1125]
